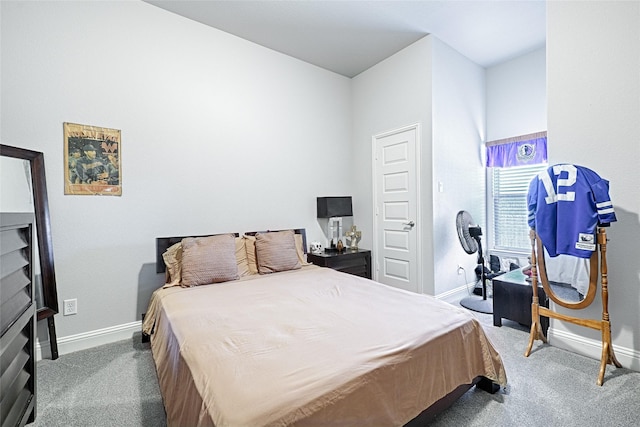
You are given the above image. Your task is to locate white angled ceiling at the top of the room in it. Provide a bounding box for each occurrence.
[145,0,546,77]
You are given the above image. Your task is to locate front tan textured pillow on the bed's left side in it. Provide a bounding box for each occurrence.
[182,234,240,286]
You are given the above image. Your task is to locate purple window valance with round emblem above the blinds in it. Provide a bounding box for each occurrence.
[487,132,547,168]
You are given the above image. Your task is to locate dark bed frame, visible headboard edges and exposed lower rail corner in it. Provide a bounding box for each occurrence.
[142,228,500,427]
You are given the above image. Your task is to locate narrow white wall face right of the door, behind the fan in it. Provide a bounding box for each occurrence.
[425,38,486,296]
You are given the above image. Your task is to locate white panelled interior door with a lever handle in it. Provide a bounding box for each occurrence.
[373,125,422,292]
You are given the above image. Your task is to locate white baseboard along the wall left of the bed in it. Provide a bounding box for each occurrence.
[36,321,142,360]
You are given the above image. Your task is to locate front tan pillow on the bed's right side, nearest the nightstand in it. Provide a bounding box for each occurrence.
[256,230,302,274]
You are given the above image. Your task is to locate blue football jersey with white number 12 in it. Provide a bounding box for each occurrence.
[527,164,617,258]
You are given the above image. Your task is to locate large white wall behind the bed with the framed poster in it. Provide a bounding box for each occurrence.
[0,2,352,352]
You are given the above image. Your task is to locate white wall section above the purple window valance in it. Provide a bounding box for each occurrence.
[486,47,547,141]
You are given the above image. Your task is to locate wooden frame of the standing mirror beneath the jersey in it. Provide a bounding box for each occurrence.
[524,227,622,386]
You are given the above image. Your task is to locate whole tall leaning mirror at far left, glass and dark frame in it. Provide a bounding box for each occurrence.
[0,145,58,320]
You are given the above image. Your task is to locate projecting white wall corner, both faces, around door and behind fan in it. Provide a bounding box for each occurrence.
[352,36,485,295]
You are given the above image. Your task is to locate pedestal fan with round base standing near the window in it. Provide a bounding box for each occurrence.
[456,211,493,314]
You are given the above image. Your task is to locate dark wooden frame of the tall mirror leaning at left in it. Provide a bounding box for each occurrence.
[0,145,59,359]
